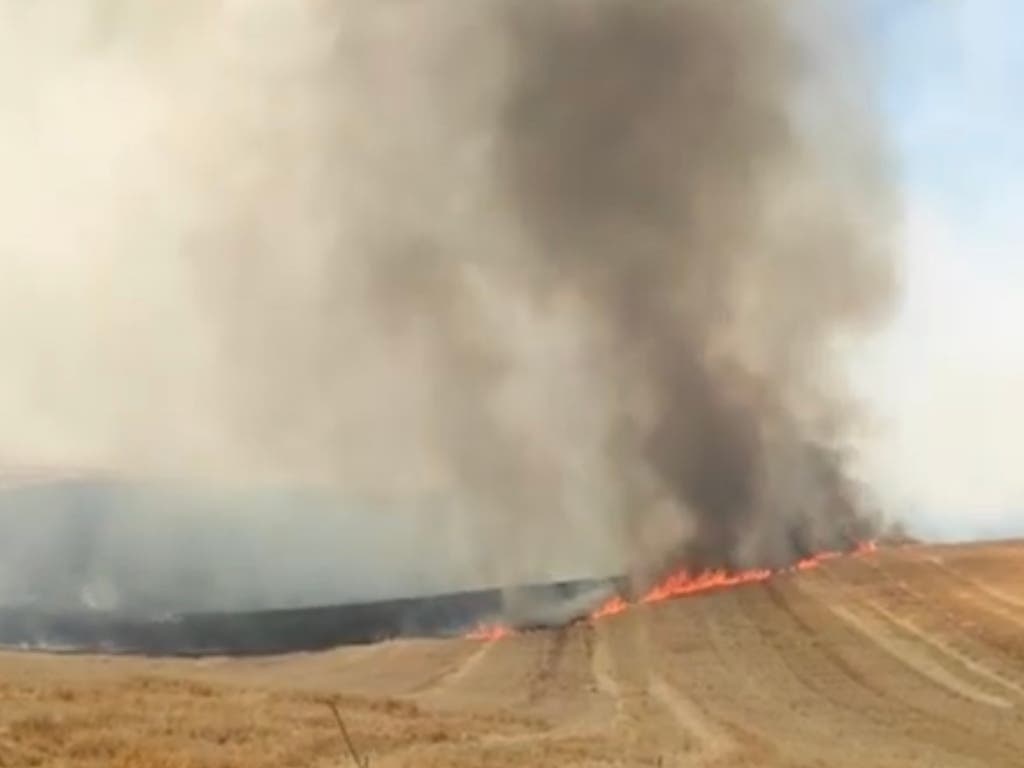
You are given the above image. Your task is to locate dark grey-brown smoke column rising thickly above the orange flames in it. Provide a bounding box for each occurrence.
[483,1,892,581]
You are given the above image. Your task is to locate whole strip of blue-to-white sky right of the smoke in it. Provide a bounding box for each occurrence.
[864,0,1024,538]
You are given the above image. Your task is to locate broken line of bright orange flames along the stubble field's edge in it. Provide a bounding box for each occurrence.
[467,542,878,640]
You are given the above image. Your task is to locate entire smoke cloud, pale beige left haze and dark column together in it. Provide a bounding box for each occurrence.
[0,0,894,602]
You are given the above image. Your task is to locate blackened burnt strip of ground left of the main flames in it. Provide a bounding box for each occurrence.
[0,580,614,656]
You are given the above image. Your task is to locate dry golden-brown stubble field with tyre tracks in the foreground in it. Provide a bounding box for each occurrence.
[0,543,1024,768]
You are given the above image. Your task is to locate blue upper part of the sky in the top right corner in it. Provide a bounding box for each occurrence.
[876,0,1024,227]
